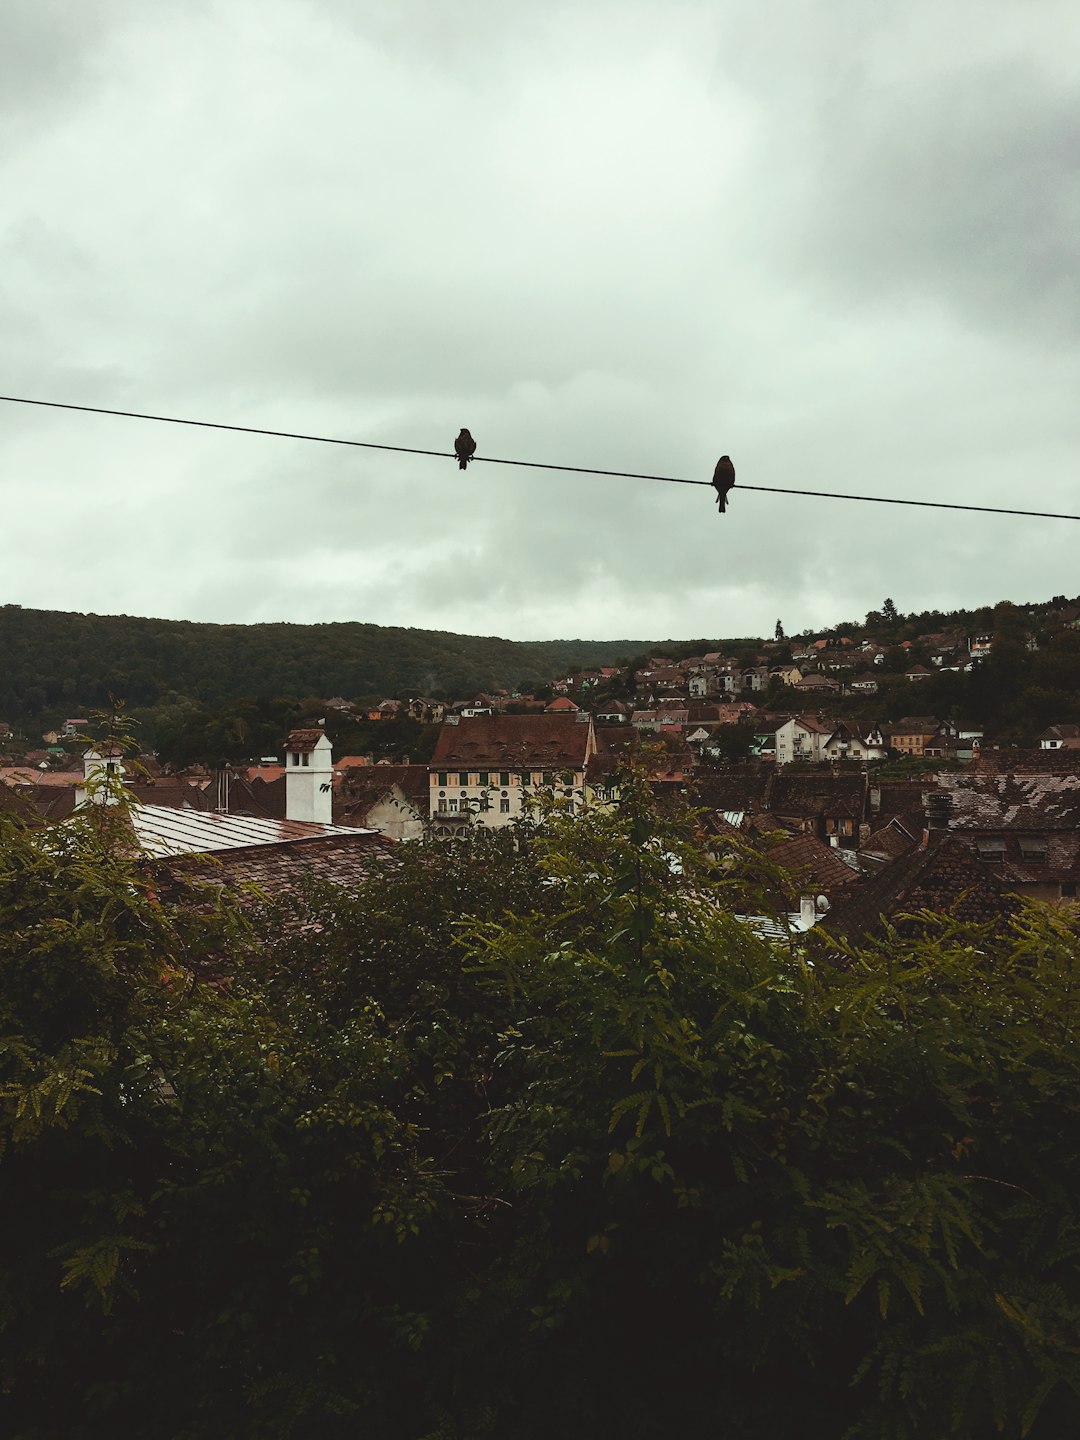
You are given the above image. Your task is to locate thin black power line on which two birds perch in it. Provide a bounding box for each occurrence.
[0,395,1080,520]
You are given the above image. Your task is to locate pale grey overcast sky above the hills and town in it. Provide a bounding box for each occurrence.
[0,0,1080,639]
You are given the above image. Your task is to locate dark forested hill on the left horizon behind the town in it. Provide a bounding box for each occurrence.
[0,605,648,720]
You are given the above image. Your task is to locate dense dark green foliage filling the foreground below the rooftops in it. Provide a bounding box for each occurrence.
[0,776,1080,1440]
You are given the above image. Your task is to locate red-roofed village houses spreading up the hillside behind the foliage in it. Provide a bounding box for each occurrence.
[0,593,1080,937]
